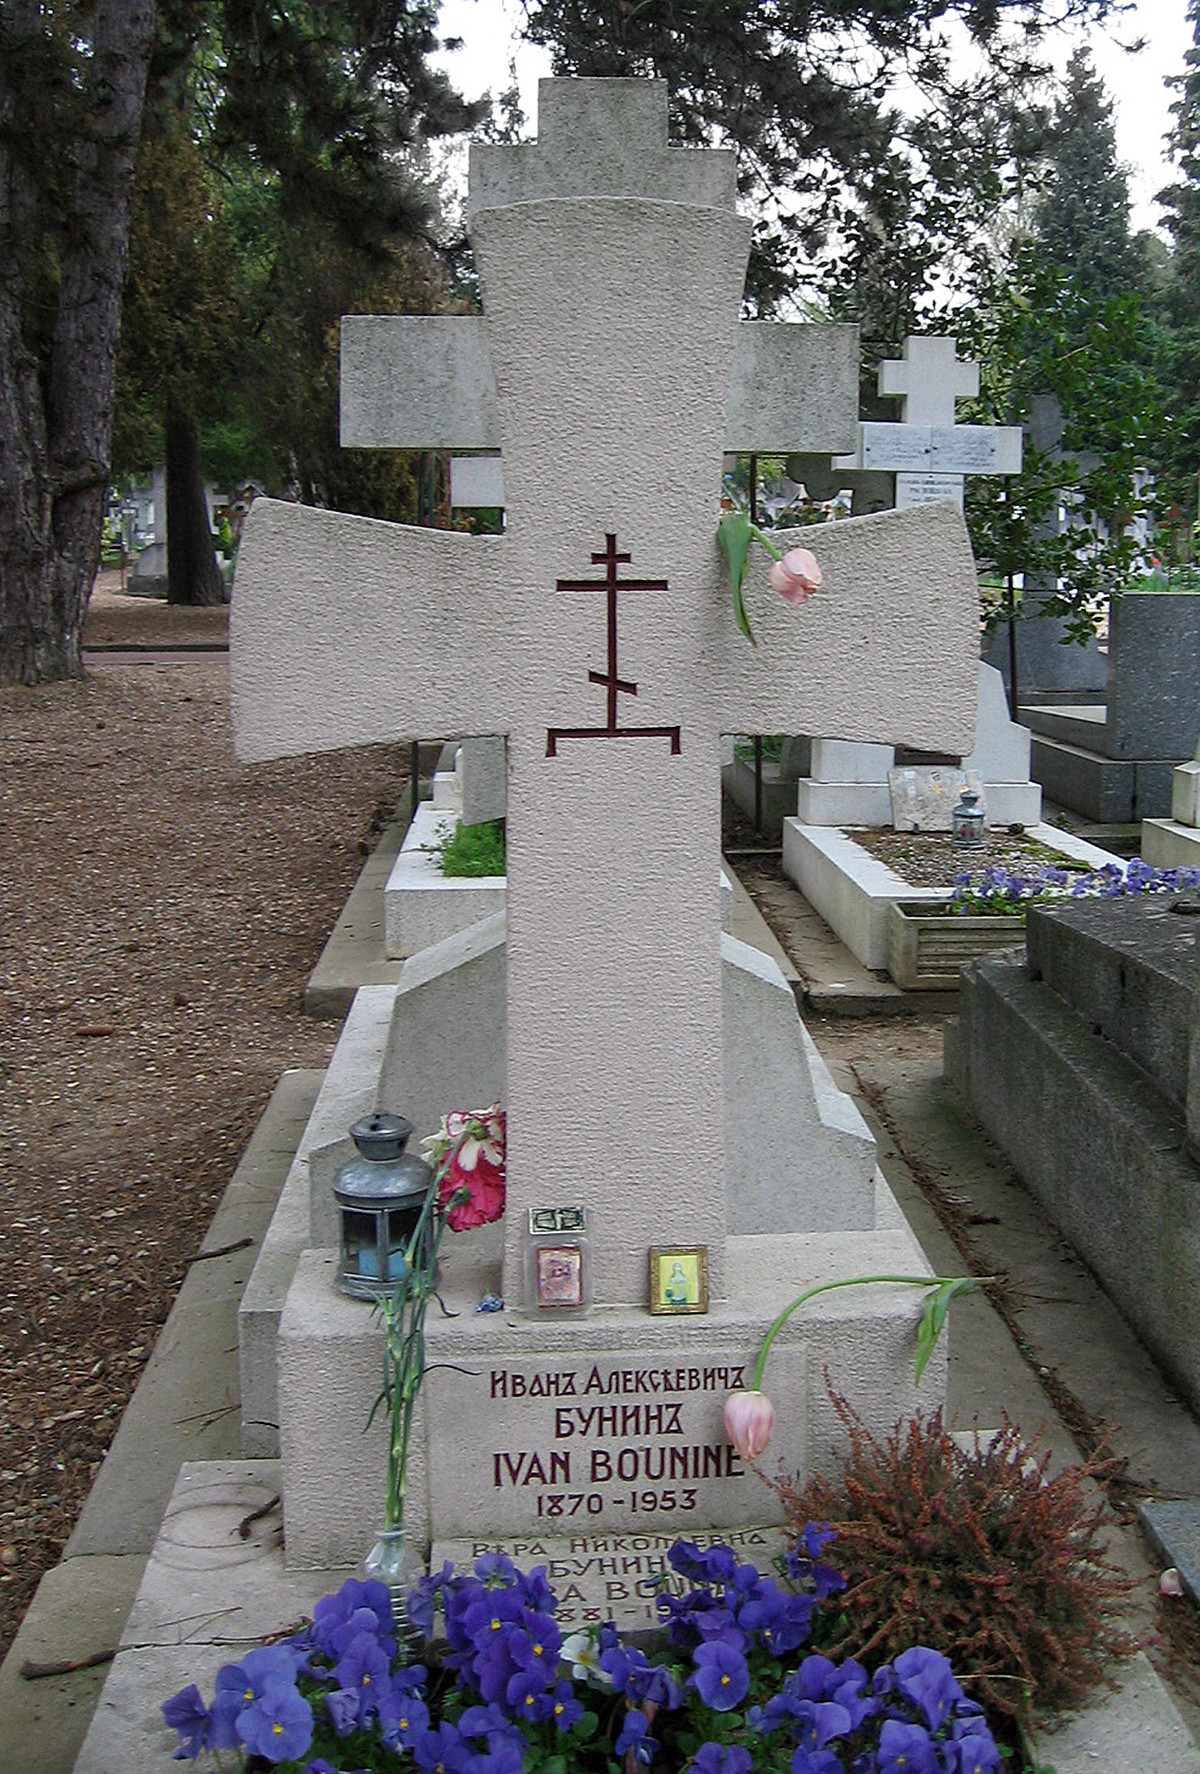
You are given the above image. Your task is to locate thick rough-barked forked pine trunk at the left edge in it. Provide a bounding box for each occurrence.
[0,0,154,683]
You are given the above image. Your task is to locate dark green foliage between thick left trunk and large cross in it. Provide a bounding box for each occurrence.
[117,0,483,520]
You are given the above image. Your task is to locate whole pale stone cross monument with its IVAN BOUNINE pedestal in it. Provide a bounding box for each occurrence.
[231,80,976,1563]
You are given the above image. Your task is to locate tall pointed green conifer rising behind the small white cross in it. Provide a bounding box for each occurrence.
[964,50,1161,701]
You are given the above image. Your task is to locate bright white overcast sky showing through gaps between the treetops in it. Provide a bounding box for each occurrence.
[438,0,1191,229]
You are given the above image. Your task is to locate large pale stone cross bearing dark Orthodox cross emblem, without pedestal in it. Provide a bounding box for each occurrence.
[231,82,978,1307]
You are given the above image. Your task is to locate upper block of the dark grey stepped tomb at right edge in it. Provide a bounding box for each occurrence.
[1026,894,1198,1111]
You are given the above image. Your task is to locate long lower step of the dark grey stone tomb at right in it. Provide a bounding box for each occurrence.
[946,951,1200,1409]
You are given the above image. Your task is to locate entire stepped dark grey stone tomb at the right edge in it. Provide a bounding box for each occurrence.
[946,894,1200,1409]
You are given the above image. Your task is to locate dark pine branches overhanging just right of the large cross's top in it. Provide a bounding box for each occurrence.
[522,0,1109,314]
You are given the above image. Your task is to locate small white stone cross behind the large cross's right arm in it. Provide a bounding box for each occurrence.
[833,337,1021,511]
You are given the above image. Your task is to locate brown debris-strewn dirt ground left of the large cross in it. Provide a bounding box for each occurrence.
[0,577,408,1655]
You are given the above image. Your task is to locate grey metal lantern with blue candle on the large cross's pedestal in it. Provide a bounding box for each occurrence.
[334,1111,433,1300]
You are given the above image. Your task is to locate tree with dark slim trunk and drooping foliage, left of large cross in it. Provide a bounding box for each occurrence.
[114,0,481,603]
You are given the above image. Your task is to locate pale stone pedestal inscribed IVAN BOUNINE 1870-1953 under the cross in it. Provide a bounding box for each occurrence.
[279,1229,946,1568]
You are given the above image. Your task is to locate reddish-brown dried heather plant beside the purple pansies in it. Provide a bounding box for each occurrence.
[772,1393,1138,1721]
